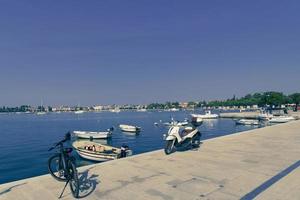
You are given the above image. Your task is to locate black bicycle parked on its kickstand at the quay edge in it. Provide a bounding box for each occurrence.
[48,133,79,198]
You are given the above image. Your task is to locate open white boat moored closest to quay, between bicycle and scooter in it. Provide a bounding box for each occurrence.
[72,141,132,162]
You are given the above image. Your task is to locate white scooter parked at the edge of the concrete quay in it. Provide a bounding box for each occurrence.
[164,126,201,155]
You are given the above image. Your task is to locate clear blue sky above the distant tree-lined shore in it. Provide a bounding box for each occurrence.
[0,0,300,105]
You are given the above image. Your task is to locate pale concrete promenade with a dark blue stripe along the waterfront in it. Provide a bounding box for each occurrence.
[0,121,300,200]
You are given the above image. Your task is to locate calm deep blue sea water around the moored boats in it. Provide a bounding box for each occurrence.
[0,111,257,184]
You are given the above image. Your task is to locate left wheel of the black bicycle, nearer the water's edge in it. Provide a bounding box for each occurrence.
[48,154,67,182]
